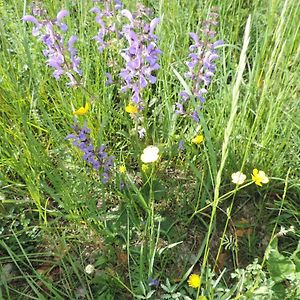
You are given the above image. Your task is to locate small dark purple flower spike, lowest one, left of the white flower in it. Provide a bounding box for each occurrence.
[66,120,114,183]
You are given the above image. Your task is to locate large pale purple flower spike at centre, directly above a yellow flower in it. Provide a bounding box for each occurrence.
[120,6,162,110]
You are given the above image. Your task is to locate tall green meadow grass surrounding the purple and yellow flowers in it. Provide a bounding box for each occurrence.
[0,0,300,299]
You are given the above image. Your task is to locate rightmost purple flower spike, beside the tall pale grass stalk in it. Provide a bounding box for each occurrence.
[176,8,223,122]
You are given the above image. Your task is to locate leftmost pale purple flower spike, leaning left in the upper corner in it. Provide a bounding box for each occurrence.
[22,9,82,86]
